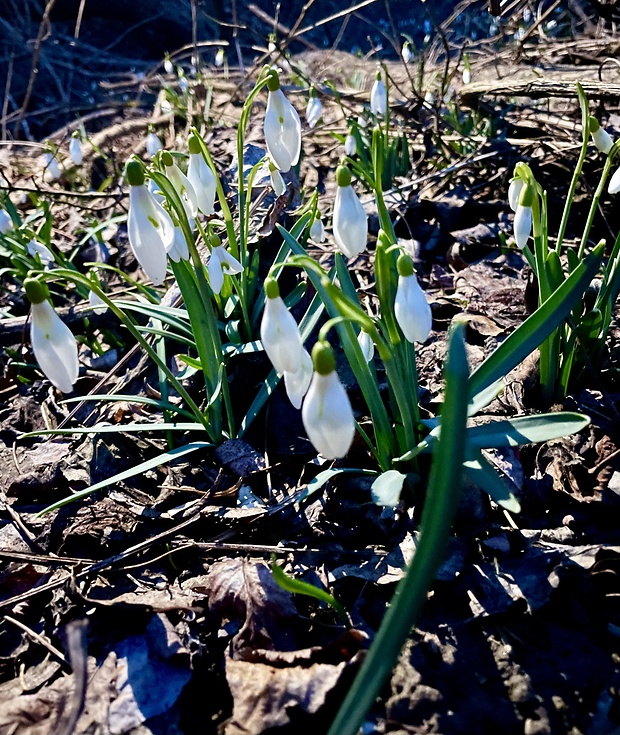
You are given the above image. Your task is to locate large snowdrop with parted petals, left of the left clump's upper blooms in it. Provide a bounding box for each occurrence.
[126,161,174,286]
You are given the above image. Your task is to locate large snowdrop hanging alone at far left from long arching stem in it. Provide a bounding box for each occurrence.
[24,278,79,393]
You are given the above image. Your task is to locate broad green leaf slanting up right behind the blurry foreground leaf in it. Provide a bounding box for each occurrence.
[469,245,604,397]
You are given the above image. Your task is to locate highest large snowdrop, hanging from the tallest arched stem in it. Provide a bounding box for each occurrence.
[264,69,301,173]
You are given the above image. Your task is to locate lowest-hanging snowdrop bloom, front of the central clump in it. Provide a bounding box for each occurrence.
[301,342,355,459]
